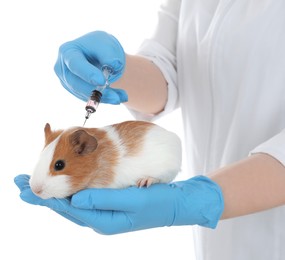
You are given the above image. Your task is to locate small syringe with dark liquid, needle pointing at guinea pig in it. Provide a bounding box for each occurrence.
[83,65,113,126]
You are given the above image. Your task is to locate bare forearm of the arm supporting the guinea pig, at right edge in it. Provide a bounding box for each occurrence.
[209,153,285,219]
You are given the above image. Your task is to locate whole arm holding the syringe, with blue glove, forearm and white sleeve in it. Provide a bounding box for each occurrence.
[54,0,181,116]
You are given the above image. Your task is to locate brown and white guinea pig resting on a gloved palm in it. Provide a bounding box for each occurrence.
[30,121,182,199]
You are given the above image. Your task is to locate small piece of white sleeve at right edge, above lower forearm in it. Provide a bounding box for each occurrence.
[250,129,285,166]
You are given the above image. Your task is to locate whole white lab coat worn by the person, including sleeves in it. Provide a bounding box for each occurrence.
[133,0,285,260]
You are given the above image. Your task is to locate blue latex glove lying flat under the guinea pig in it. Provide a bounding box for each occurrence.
[15,175,224,234]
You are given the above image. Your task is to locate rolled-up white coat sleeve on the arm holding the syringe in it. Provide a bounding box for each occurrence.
[127,0,180,120]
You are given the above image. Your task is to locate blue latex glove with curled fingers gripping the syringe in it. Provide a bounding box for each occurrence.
[54,31,128,104]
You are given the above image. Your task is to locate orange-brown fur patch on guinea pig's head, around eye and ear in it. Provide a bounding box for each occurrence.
[47,128,118,191]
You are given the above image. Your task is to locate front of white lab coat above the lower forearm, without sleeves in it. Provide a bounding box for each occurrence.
[177,0,285,173]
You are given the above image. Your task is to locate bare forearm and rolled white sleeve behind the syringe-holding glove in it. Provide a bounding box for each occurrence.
[113,0,181,116]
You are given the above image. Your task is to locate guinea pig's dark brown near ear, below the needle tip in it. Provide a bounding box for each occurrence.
[69,130,98,155]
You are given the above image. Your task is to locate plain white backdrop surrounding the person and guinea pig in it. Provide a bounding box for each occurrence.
[0,0,194,260]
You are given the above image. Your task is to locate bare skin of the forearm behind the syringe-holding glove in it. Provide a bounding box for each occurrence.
[112,55,167,114]
